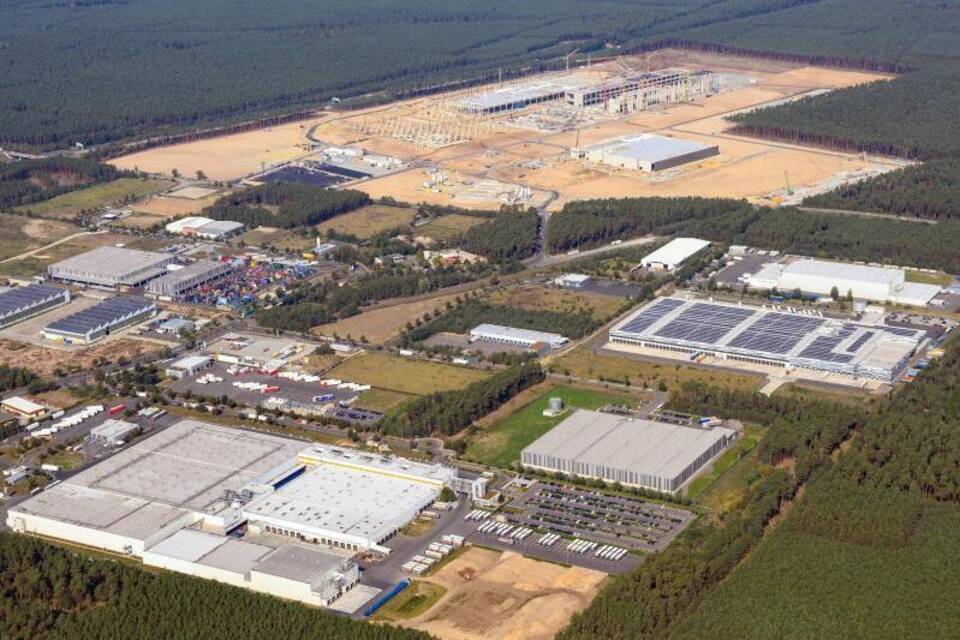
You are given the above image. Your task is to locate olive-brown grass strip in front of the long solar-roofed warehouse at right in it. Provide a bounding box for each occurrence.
[550,345,763,390]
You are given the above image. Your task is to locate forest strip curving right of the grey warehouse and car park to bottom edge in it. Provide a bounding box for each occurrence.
[558,378,865,640]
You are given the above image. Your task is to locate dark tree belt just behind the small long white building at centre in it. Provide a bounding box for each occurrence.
[404,300,600,343]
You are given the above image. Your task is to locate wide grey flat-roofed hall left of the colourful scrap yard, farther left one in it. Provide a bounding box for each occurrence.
[47,247,174,288]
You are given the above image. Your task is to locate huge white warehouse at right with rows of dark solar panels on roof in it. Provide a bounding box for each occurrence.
[609,297,926,382]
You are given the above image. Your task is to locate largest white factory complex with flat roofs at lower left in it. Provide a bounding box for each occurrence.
[7,420,472,606]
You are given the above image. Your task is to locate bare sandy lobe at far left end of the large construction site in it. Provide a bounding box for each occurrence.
[111,119,320,180]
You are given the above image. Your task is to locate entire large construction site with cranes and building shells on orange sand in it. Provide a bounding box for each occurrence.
[114,49,904,210]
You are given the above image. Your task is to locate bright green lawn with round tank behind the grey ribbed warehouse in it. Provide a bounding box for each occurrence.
[464,386,636,468]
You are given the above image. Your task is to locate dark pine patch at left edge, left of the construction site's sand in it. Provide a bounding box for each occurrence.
[0,158,134,211]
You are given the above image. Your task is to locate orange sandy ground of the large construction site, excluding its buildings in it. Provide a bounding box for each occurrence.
[114,50,897,210]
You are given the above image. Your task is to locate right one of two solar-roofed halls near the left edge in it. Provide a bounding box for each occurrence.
[43,296,157,344]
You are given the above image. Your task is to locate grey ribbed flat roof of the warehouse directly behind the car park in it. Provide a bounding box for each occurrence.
[523,409,735,478]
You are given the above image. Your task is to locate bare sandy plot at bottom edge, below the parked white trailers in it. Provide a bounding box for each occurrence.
[402,548,606,640]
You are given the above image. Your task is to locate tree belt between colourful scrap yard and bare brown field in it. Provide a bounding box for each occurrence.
[256,265,489,331]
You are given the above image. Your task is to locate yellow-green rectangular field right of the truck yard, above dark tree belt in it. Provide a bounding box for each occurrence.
[326,351,491,396]
